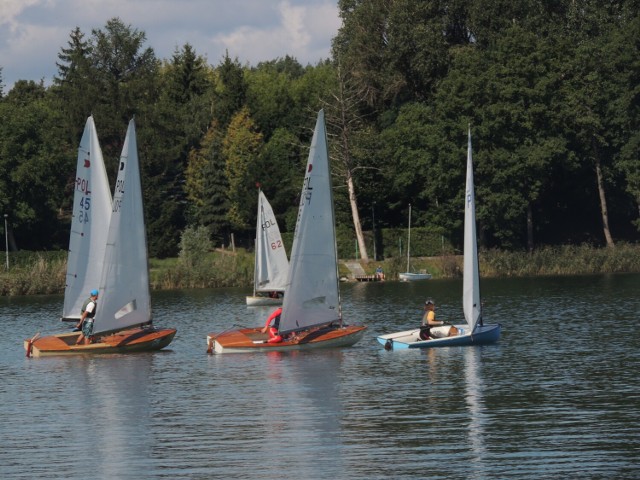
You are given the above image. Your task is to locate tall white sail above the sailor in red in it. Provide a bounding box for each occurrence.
[280,110,340,334]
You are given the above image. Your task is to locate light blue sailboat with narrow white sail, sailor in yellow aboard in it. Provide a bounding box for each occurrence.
[377,130,501,350]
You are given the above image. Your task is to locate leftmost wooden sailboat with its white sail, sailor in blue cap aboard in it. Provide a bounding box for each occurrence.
[24,120,176,356]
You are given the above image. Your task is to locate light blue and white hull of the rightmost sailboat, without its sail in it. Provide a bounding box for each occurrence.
[376,323,501,350]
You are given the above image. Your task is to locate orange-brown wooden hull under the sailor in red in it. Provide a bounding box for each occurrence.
[207,325,367,353]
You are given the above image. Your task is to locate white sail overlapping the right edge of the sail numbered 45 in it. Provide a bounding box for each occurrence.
[93,120,151,334]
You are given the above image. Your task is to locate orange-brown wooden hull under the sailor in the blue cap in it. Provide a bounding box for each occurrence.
[24,328,176,357]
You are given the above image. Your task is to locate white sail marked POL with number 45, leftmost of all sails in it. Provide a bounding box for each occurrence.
[62,117,111,319]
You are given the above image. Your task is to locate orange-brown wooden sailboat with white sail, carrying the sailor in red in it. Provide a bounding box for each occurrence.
[207,110,367,353]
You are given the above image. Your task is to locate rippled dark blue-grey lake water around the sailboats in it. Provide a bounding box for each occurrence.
[0,275,640,479]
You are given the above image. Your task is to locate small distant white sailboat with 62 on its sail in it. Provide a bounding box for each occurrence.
[247,190,289,306]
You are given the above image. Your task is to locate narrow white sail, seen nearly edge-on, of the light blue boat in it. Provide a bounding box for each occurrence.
[462,129,482,332]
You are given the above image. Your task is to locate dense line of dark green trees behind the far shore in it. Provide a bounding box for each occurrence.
[0,0,640,259]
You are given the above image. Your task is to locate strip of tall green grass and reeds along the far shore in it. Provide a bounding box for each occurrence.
[0,244,640,296]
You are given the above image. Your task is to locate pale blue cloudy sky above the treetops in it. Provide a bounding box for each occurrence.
[0,0,340,94]
